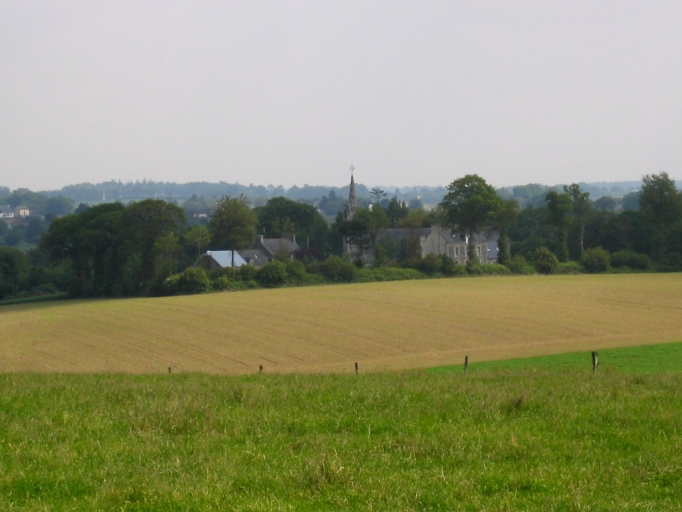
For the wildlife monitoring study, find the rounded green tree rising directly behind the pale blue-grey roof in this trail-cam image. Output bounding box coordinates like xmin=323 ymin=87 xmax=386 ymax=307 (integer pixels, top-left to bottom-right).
xmin=208 ymin=195 xmax=257 ymax=265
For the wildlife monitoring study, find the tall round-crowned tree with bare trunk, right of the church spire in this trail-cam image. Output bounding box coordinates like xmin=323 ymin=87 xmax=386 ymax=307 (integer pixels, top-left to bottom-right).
xmin=441 ymin=174 xmax=502 ymax=263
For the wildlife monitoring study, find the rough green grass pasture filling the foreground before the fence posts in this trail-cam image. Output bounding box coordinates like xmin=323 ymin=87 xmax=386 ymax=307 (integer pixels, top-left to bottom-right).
xmin=0 ymin=368 xmax=682 ymax=511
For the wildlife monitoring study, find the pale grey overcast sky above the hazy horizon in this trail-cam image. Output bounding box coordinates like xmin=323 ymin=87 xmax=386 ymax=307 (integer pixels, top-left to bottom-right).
xmin=0 ymin=0 xmax=682 ymax=190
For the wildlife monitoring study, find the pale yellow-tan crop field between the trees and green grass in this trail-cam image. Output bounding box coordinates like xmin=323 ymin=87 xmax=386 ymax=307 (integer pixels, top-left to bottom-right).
xmin=0 ymin=274 xmax=682 ymax=374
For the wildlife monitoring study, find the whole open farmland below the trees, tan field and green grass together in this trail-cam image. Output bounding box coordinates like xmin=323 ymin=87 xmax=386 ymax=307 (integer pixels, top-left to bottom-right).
xmin=0 ymin=274 xmax=682 ymax=511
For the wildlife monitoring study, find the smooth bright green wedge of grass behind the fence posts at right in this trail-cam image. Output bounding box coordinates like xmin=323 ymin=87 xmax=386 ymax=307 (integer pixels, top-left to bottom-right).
xmin=429 ymin=343 xmax=682 ymax=374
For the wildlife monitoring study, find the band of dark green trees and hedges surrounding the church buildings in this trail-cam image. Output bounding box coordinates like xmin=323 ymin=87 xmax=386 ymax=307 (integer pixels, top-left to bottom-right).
xmin=0 ymin=173 xmax=682 ymax=299
